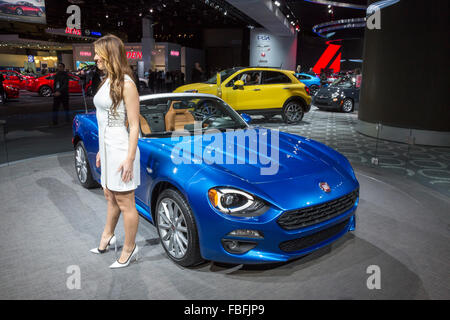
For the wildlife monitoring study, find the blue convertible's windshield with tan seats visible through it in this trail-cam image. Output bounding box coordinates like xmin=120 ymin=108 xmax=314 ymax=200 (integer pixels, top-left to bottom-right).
xmin=140 ymin=94 xmax=248 ymax=137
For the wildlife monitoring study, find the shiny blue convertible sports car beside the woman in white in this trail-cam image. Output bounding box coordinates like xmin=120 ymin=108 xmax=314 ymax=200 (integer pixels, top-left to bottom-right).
xmin=73 ymin=93 xmax=359 ymax=266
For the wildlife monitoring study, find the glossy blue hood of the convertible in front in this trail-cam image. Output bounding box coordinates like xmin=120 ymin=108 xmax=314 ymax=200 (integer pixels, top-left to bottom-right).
xmin=146 ymin=128 xmax=350 ymax=184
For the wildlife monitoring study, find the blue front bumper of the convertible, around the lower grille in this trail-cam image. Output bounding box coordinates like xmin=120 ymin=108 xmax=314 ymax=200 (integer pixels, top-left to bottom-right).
xmin=194 ymin=197 xmax=359 ymax=264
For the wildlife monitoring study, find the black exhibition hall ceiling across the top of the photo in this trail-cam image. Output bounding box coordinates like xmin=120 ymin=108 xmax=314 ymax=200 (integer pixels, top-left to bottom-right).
xmin=0 ymin=0 xmax=367 ymax=48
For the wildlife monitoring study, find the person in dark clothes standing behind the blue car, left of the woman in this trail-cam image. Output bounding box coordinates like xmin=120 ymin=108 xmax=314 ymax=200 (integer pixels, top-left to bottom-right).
xmin=53 ymin=63 xmax=70 ymax=125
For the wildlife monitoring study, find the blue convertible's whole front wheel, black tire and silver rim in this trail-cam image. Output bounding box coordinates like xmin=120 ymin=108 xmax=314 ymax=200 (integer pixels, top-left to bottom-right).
xmin=155 ymin=188 xmax=204 ymax=267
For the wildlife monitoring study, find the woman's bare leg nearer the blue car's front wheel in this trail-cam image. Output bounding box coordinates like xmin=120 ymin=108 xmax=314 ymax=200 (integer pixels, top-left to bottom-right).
xmin=114 ymin=190 xmax=139 ymax=263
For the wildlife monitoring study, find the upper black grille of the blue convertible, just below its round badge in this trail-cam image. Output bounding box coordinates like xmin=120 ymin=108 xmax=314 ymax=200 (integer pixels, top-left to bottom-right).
xmin=277 ymin=189 xmax=359 ymax=230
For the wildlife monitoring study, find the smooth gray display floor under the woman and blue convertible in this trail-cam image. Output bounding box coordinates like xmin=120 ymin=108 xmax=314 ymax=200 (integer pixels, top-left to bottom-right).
xmin=0 ymin=153 xmax=450 ymax=300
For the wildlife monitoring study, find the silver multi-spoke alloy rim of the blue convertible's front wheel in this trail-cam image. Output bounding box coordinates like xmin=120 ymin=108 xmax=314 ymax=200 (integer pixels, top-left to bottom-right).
xmin=157 ymin=198 xmax=189 ymax=259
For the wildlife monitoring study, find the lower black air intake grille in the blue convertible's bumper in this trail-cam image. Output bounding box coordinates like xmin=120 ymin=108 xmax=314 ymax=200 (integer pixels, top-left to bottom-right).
xmin=279 ymin=219 xmax=350 ymax=252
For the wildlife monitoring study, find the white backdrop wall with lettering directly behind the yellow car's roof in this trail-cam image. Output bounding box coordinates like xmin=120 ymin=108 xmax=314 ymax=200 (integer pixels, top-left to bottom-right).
xmin=250 ymin=29 xmax=297 ymax=70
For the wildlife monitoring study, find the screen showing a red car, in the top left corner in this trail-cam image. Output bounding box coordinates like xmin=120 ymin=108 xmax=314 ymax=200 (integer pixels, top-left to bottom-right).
xmin=0 ymin=0 xmax=47 ymax=24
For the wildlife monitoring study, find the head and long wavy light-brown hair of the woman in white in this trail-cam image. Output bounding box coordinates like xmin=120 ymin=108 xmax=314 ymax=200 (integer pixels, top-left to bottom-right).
xmin=94 ymin=34 xmax=133 ymax=115
